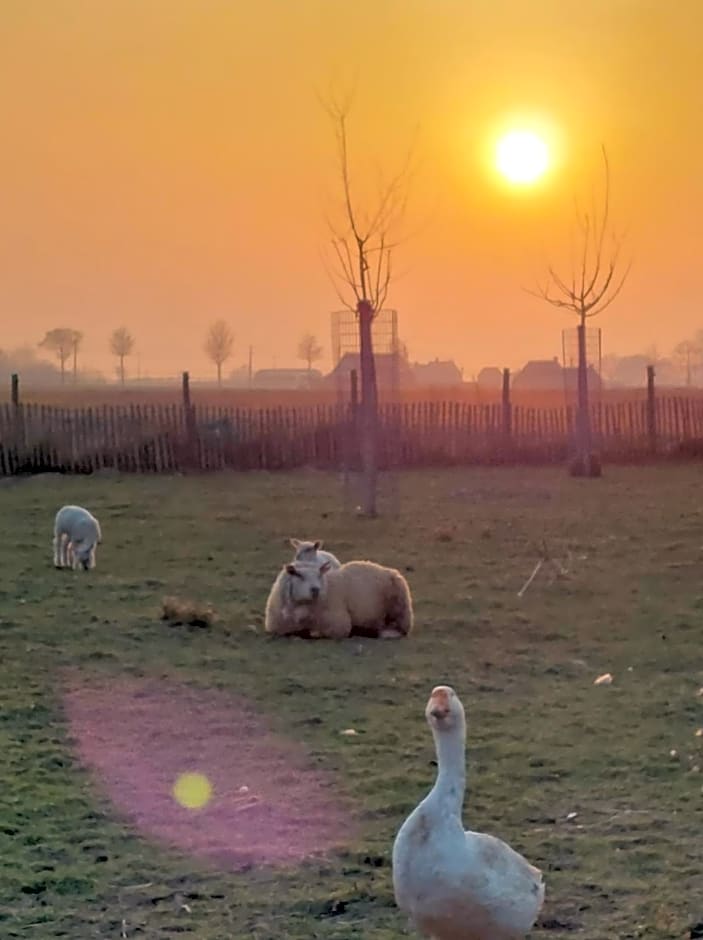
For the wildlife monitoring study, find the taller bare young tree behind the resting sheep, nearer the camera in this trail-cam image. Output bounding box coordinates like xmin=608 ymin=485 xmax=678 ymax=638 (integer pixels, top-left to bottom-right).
xmin=324 ymin=98 xmax=410 ymax=516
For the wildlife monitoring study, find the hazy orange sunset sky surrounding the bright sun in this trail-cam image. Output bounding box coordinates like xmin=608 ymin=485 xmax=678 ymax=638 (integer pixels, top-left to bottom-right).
xmin=0 ymin=0 xmax=703 ymax=375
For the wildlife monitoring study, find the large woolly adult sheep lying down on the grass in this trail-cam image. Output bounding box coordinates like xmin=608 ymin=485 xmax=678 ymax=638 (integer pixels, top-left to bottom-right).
xmin=266 ymin=561 xmax=413 ymax=639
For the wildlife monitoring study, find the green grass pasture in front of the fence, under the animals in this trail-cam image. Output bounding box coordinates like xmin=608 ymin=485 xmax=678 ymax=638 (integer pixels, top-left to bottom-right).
xmin=0 ymin=466 xmax=703 ymax=940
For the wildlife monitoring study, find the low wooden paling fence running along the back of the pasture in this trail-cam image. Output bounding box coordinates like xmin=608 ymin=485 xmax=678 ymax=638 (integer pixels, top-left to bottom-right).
xmin=0 ymin=397 xmax=703 ymax=476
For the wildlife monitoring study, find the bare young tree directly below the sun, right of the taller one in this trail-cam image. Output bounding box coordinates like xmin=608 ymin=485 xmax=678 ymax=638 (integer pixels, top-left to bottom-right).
xmin=528 ymin=146 xmax=631 ymax=476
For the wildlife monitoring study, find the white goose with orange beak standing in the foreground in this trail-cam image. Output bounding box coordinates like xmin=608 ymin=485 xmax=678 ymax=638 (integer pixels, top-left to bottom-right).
xmin=393 ymin=685 xmax=545 ymax=940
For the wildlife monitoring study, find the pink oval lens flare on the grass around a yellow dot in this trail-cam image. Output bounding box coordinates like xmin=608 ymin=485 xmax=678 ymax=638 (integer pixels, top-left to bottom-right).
xmin=64 ymin=675 xmax=355 ymax=870
